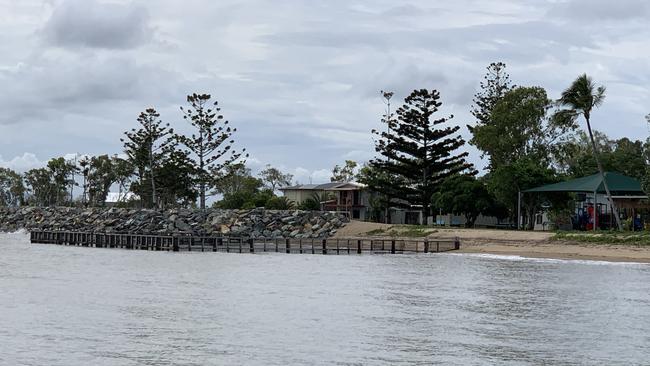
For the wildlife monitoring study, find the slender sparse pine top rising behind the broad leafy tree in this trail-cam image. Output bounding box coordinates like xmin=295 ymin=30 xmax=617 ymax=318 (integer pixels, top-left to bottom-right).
xmin=467 ymin=62 xmax=514 ymax=145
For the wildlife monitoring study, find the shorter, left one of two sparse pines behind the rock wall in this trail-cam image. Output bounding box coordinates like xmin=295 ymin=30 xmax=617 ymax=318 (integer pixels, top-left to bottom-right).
xmin=121 ymin=108 xmax=176 ymax=207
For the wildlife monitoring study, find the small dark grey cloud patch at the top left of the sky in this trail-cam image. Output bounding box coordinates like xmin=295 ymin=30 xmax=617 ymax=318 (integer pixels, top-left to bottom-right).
xmin=43 ymin=0 xmax=152 ymax=49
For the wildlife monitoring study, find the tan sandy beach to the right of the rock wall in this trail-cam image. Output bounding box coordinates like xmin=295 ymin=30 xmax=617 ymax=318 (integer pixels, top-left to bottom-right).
xmin=336 ymin=221 xmax=650 ymax=263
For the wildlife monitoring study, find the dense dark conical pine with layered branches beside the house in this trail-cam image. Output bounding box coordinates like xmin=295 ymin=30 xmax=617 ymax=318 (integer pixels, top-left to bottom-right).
xmin=370 ymin=89 xmax=472 ymax=222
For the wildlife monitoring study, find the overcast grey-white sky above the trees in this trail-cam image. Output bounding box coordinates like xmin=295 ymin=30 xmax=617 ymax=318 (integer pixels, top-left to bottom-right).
xmin=0 ymin=0 xmax=650 ymax=183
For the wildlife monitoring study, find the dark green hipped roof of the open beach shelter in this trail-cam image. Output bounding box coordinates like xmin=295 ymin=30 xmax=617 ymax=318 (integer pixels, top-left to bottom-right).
xmin=524 ymin=172 xmax=646 ymax=196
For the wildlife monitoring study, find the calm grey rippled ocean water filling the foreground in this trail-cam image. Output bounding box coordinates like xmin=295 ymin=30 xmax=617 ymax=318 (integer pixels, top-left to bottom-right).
xmin=0 ymin=234 xmax=650 ymax=366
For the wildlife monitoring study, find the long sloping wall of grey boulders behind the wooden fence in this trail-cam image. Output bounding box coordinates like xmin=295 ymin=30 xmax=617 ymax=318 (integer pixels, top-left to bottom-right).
xmin=0 ymin=207 xmax=347 ymax=238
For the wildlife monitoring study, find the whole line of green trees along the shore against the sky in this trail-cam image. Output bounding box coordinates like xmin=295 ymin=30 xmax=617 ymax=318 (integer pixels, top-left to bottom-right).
xmin=0 ymin=62 xmax=650 ymax=225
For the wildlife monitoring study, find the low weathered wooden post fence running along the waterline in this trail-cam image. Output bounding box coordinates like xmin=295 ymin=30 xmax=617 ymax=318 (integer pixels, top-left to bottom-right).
xmin=30 ymin=231 xmax=460 ymax=254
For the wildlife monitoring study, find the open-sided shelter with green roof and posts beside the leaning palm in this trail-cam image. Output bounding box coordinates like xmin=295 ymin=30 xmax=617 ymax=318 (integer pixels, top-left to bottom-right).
xmin=517 ymin=172 xmax=649 ymax=230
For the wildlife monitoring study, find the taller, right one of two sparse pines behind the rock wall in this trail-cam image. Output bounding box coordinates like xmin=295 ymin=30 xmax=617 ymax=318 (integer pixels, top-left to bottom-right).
xmin=179 ymin=93 xmax=248 ymax=209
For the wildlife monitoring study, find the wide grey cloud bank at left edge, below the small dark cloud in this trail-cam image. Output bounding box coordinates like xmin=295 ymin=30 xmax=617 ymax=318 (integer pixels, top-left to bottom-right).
xmin=0 ymin=55 xmax=180 ymax=124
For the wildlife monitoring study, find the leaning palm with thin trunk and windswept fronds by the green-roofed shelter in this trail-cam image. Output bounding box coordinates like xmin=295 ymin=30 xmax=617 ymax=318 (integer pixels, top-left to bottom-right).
xmin=558 ymin=74 xmax=623 ymax=230
